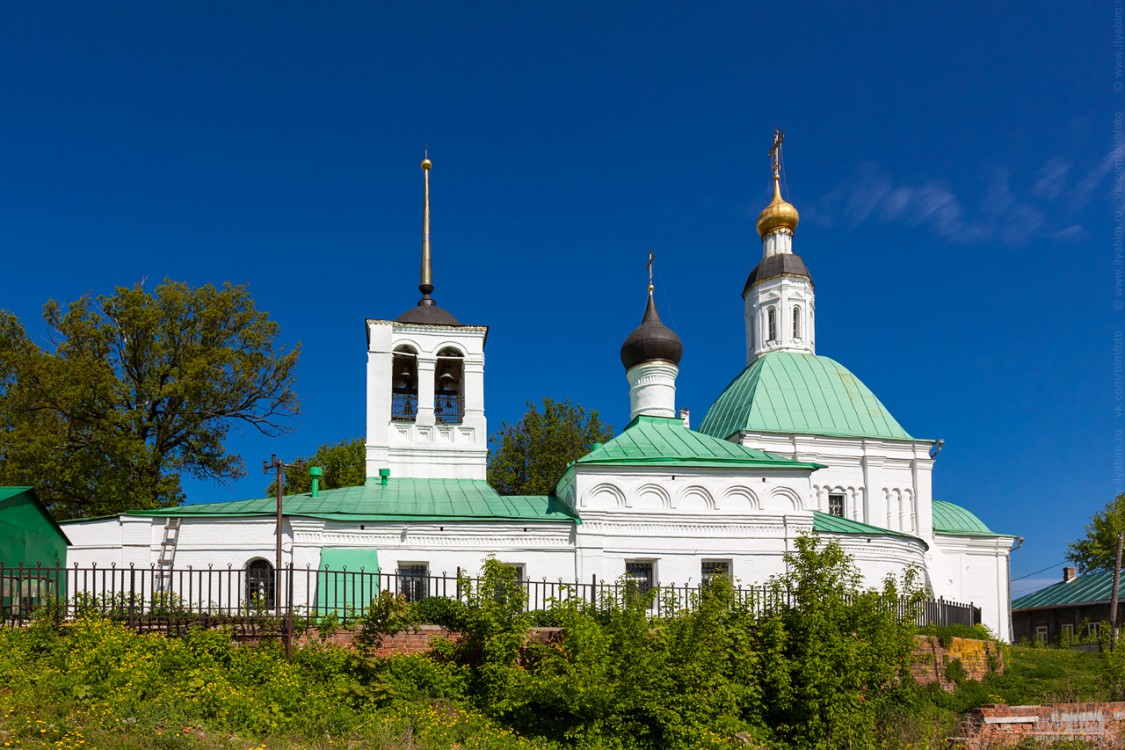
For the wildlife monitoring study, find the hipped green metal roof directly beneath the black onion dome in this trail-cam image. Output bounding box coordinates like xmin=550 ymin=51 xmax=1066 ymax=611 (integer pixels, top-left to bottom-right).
xmin=575 ymin=416 xmax=824 ymax=470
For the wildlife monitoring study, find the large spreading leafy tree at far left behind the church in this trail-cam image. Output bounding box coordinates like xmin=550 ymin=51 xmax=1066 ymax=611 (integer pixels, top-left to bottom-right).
xmin=0 ymin=280 xmax=299 ymax=516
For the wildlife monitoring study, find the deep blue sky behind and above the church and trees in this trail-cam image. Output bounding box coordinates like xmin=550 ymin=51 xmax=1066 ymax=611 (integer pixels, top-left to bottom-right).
xmin=0 ymin=2 xmax=1125 ymax=594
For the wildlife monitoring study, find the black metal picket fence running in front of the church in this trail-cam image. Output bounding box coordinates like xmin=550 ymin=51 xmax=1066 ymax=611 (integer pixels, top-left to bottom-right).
xmin=0 ymin=564 xmax=981 ymax=635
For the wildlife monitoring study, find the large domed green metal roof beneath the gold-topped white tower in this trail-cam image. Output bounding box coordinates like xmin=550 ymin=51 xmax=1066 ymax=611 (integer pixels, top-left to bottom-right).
xmin=699 ymin=352 xmax=914 ymax=440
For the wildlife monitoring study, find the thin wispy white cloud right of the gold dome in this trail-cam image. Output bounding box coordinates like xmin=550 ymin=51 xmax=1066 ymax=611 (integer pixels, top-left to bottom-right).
xmin=802 ymin=146 xmax=1125 ymax=245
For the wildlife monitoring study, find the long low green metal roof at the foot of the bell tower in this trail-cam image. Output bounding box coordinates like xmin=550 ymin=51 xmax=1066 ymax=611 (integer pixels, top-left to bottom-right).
xmin=128 ymin=477 xmax=576 ymax=523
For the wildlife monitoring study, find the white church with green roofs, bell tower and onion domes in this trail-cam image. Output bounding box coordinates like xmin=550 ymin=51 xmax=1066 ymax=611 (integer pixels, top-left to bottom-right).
xmin=65 ymin=135 xmax=1016 ymax=639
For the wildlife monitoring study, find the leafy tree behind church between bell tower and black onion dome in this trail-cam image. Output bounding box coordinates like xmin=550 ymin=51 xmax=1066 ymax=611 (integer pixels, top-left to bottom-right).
xmin=488 ymin=398 xmax=613 ymax=495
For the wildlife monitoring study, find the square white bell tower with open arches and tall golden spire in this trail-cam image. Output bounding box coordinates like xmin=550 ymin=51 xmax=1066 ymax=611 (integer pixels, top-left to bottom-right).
xmin=367 ymin=156 xmax=488 ymax=479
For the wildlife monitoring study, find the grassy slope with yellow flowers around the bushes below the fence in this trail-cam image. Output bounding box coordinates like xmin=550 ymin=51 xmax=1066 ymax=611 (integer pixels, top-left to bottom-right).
xmin=0 ymin=621 xmax=1125 ymax=750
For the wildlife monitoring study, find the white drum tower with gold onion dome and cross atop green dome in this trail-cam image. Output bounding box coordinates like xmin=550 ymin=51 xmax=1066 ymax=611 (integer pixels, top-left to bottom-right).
xmin=743 ymin=130 xmax=817 ymax=364
